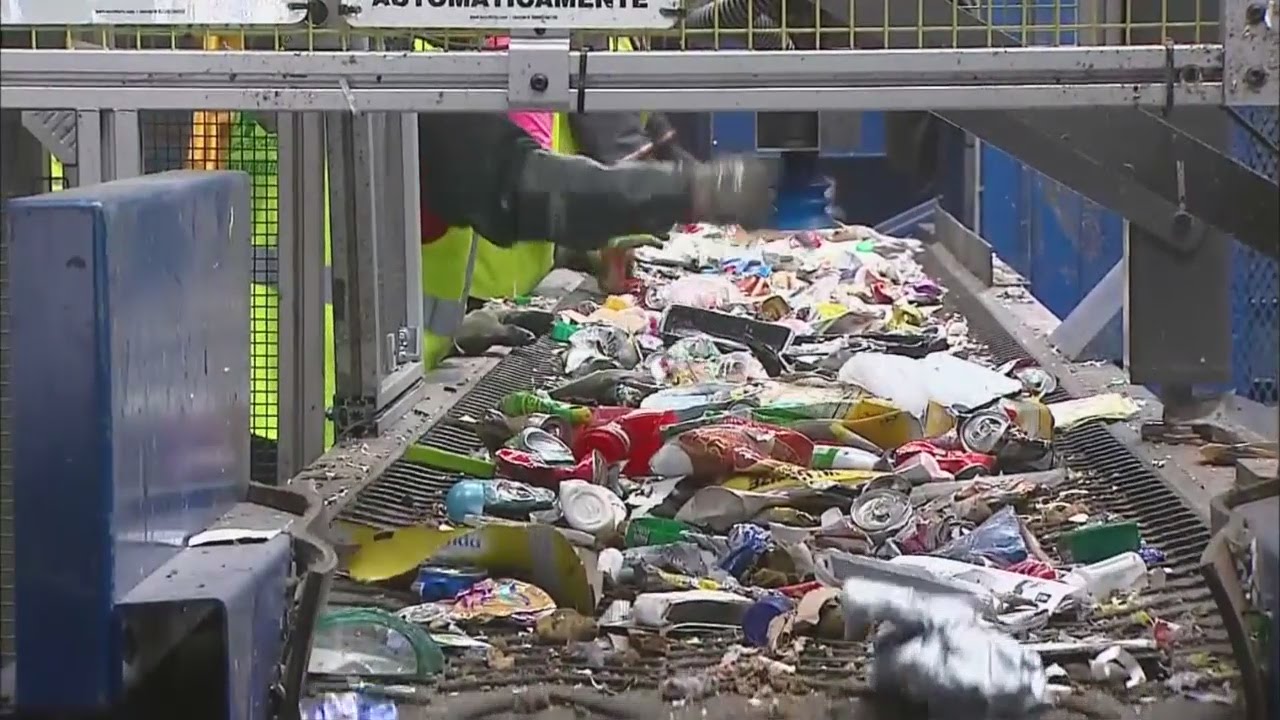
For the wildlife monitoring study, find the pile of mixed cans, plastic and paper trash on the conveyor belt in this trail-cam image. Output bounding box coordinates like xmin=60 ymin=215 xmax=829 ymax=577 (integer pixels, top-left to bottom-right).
xmin=305 ymin=225 xmax=1224 ymax=717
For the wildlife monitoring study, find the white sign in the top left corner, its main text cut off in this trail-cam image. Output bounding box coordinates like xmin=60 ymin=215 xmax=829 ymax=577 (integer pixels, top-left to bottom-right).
xmin=0 ymin=0 xmax=306 ymax=26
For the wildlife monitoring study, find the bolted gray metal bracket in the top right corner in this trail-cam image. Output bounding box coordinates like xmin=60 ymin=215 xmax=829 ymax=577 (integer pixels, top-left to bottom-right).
xmin=1222 ymin=0 xmax=1280 ymax=106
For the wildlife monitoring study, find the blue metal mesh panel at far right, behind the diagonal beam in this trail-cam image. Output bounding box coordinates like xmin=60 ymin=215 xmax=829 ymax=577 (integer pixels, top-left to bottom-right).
xmin=1231 ymin=108 xmax=1280 ymax=405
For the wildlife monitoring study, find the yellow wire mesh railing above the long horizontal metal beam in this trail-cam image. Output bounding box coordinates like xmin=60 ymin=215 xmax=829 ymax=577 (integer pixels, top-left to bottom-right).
xmin=6 ymin=0 xmax=1220 ymax=50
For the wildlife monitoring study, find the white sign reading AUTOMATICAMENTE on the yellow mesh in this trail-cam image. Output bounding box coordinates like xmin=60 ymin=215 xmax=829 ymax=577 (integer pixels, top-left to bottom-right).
xmin=347 ymin=0 xmax=680 ymax=29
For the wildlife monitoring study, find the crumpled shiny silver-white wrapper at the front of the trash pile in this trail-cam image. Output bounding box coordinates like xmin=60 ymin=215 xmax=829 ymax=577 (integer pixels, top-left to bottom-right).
xmin=841 ymin=578 xmax=1048 ymax=720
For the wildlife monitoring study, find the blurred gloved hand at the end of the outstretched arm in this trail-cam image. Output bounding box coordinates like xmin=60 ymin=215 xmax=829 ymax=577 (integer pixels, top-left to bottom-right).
xmin=681 ymin=156 xmax=774 ymax=229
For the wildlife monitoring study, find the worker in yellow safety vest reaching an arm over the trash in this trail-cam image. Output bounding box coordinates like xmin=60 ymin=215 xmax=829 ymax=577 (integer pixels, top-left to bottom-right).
xmin=419 ymin=113 xmax=772 ymax=363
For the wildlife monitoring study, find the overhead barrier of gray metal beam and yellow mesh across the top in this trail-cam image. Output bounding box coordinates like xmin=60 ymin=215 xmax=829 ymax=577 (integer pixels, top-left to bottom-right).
xmin=4 ymin=0 xmax=1280 ymax=111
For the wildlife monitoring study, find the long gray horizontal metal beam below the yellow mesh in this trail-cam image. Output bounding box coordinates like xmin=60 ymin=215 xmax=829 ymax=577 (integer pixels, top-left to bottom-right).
xmin=0 ymin=42 xmax=1224 ymax=114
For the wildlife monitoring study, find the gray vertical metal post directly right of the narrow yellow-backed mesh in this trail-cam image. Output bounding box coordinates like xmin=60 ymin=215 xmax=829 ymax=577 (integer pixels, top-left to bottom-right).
xmin=276 ymin=113 xmax=333 ymax=482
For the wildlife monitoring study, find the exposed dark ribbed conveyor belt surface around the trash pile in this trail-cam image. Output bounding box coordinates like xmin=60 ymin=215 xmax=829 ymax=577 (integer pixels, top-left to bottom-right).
xmin=333 ymin=249 xmax=1229 ymax=694
